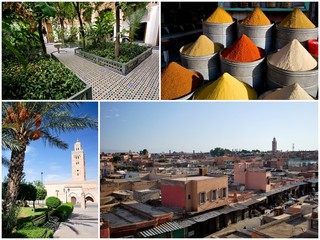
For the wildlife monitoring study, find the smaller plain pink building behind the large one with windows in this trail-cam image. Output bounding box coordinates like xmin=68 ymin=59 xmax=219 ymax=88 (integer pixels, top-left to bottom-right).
xmin=234 ymin=162 xmax=271 ymax=192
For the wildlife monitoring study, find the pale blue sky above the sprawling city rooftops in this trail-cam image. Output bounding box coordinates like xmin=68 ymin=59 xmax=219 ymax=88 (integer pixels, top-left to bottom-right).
xmin=100 ymin=101 xmax=318 ymax=153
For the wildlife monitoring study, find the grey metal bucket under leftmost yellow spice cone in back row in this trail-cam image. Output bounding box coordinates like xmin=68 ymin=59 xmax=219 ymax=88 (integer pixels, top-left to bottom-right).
xmin=202 ymin=21 xmax=237 ymax=47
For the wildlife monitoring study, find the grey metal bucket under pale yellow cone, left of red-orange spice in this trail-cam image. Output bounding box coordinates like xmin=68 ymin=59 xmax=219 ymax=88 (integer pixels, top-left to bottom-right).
xmin=180 ymin=43 xmax=223 ymax=81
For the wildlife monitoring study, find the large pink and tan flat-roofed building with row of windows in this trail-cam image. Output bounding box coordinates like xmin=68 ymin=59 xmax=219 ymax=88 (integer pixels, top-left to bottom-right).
xmin=161 ymin=176 xmax=228 ymax=212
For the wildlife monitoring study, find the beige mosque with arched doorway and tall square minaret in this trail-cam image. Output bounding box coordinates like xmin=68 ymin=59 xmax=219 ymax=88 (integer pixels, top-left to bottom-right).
xmin=44 ymin=140 xmax=99 ymax=208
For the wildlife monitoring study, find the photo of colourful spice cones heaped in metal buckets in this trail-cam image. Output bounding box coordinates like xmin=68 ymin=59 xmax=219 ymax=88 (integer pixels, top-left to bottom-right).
xmin=161 ymin=1 xmax=318 ymax=100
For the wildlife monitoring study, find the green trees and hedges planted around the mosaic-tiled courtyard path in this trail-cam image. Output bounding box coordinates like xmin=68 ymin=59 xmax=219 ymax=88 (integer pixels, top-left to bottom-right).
xmin=2 ymin=2 xmax=151 ymax=100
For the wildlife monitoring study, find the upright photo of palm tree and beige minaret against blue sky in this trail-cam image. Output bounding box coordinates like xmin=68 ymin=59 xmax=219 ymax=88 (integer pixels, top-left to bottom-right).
xmin=2 ymin=102 xmax=99 ymax=238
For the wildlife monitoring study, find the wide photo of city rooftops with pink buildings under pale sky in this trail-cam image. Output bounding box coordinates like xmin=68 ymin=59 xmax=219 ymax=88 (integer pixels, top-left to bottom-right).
xmin=100 ymin=101 xmax=319 ymax=238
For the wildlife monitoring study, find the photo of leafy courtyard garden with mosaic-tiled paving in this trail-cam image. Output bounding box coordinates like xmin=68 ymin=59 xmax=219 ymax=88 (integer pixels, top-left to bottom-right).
xmin=1 ymin=2 xmax=160 ymax=100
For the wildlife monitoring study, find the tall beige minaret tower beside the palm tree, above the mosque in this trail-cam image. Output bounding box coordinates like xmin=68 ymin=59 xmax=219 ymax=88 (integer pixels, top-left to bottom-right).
xmin=71 ymin=139 xmax=86 ymax=182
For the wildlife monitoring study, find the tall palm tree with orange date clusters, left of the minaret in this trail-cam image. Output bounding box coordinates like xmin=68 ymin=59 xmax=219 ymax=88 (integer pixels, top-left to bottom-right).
xmin=2 ymin=102 xmax=98 ymax=219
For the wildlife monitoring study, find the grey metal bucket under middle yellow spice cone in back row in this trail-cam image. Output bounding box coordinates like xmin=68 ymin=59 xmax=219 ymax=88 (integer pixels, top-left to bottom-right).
xmin=237 ymin=22 xmax=274 ymax=53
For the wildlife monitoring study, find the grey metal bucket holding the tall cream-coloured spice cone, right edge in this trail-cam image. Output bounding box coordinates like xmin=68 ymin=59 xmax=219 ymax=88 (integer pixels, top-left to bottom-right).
xmin=267 ymin=54 xmax=318 ymax=98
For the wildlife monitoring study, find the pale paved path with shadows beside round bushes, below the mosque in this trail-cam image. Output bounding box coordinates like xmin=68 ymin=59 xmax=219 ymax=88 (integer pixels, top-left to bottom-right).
xmin=53 ymin=203 xmax=99 ymax=238
